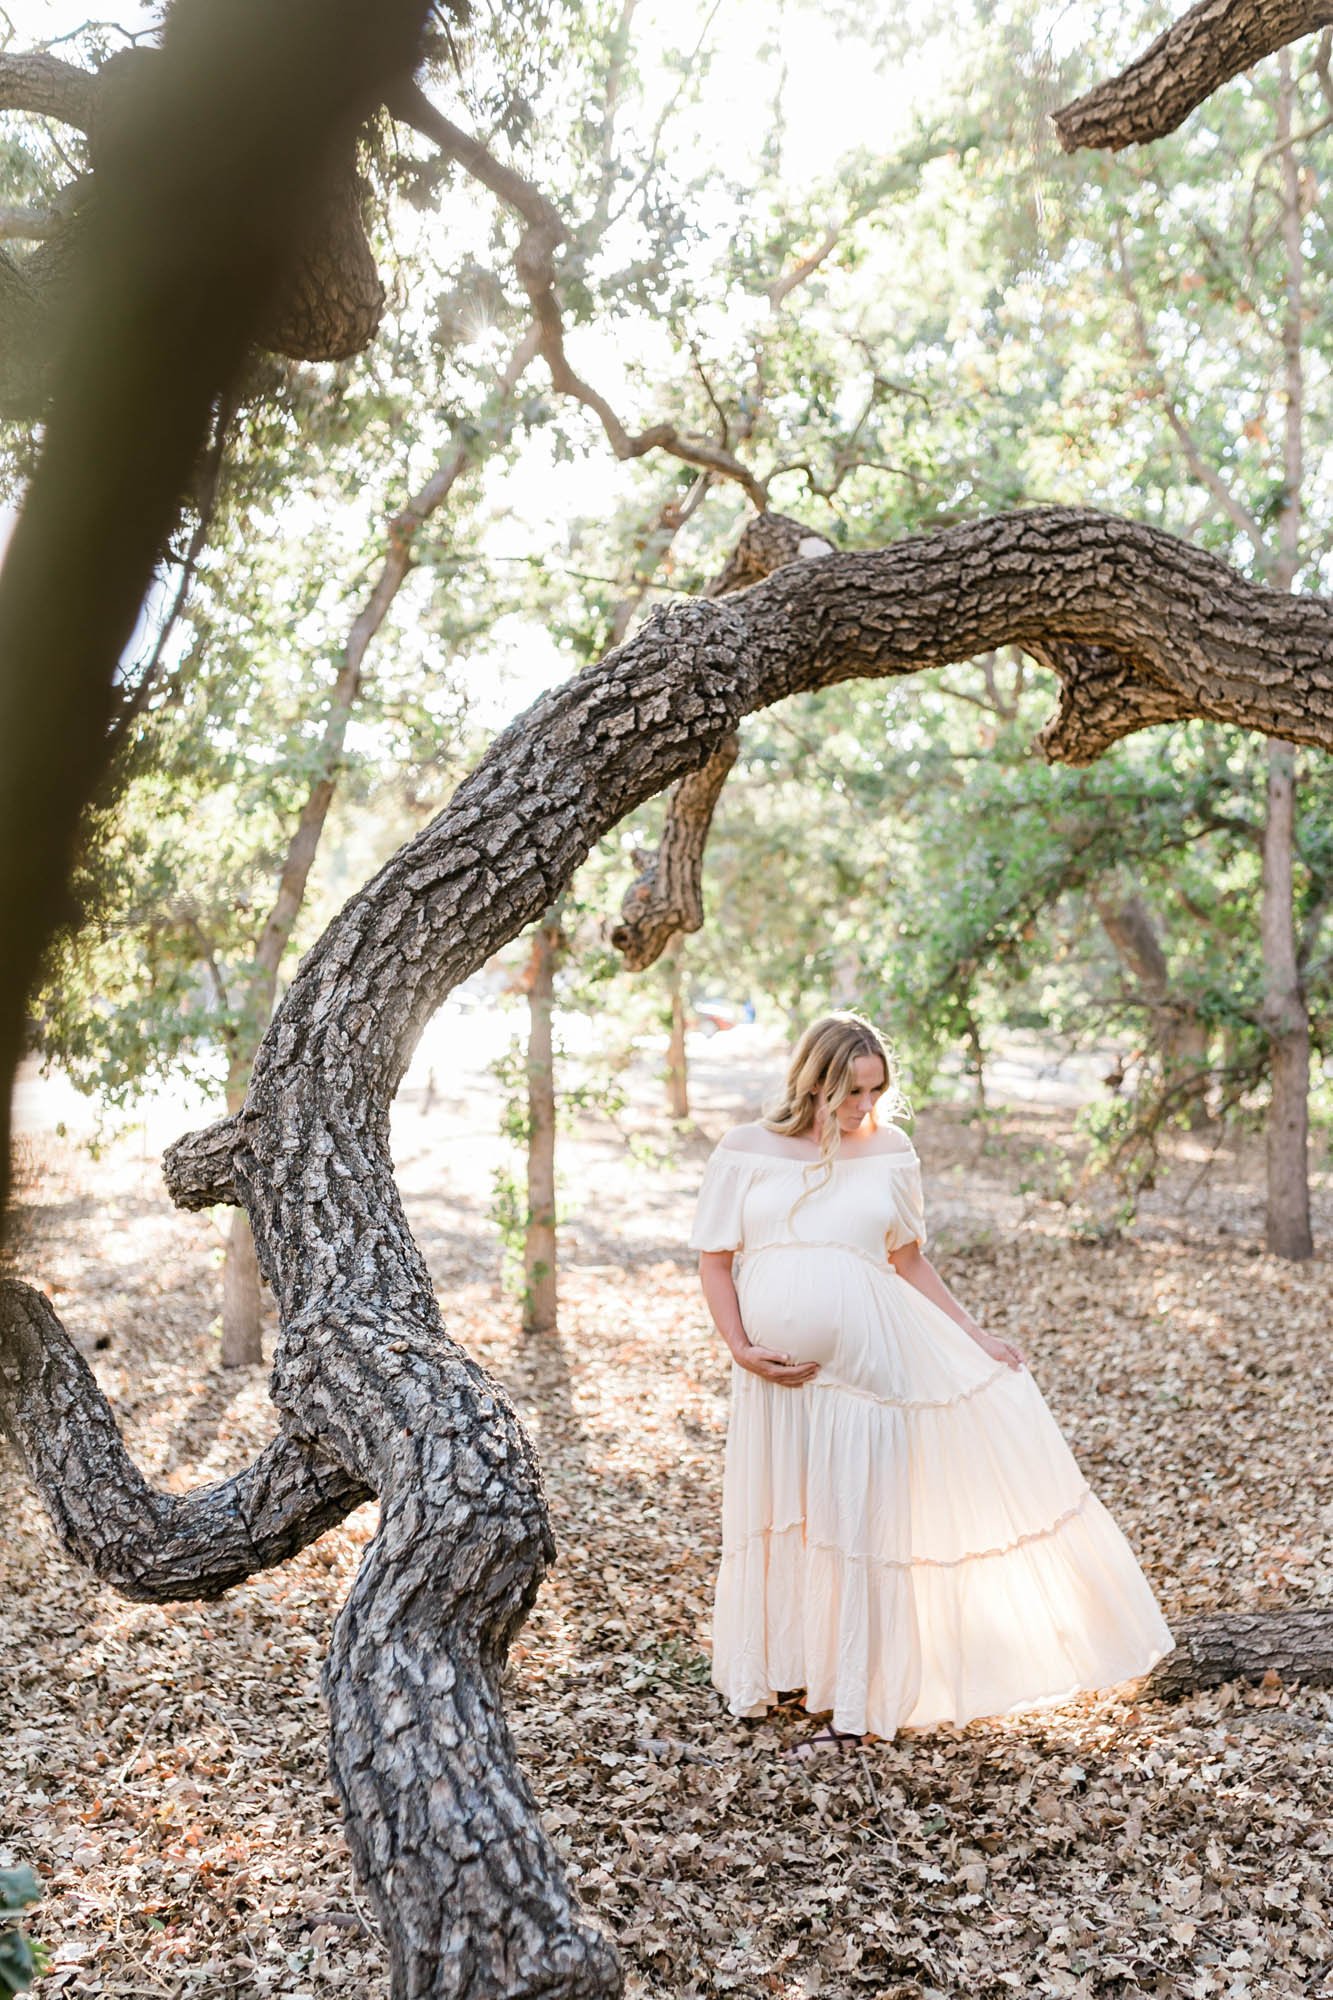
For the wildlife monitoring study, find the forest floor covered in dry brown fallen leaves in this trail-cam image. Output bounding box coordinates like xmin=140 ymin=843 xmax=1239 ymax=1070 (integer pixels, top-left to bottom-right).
xmin=0 ymin=1030 xmax=1333 ymax=2000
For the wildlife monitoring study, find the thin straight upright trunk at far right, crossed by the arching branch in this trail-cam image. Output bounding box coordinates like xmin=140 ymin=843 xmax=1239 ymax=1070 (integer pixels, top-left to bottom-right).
xmin=1261 ymin=50 xmax=1315 ymax=1258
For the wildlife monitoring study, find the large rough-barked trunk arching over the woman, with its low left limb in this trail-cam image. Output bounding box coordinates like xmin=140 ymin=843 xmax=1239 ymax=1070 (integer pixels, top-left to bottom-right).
xmin=13 ymin=508 xmax=1333 ymax=2000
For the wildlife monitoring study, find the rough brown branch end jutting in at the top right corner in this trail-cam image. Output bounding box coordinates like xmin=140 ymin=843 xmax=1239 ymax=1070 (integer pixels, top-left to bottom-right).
xmin=1051 ymin=0 xmax=1333 ymax=152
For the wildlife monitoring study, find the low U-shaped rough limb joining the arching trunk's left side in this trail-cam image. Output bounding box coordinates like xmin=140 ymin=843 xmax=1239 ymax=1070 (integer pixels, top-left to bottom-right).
xmin=0 ymin=1280 xmax=372 ymax=1604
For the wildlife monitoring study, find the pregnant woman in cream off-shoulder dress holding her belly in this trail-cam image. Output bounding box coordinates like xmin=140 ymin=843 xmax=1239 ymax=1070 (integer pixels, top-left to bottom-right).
xmin=691 ymin=1012 xmax=1173 ymax=1752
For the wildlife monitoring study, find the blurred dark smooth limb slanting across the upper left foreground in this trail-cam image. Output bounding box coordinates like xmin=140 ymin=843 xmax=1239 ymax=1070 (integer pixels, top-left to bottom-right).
xmin=0 ymin=0 xmax=430 ymax=1214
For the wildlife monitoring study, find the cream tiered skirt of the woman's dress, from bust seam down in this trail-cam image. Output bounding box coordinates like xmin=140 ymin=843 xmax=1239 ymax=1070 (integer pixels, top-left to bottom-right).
xmin=713 ymin=1244 xmax=1173 ymax=1738
